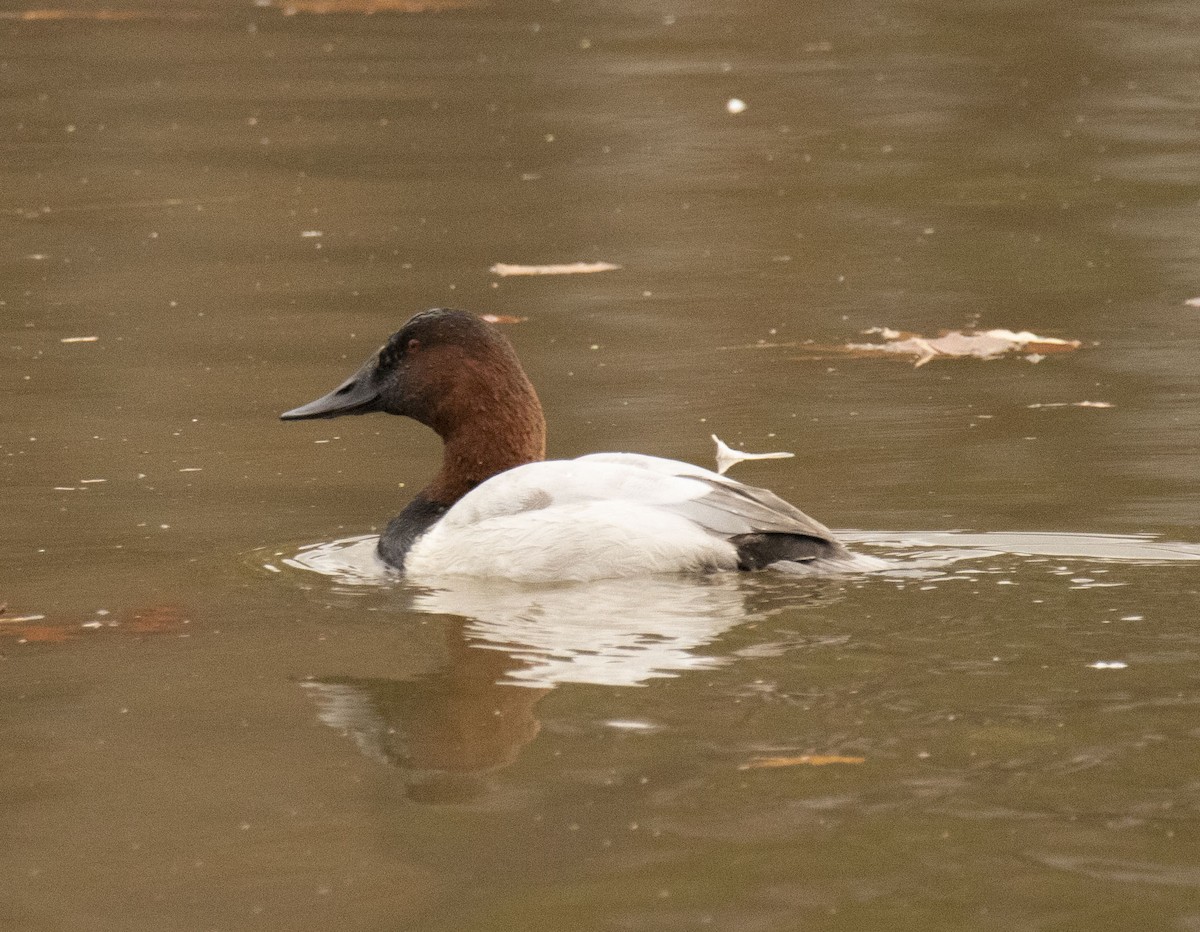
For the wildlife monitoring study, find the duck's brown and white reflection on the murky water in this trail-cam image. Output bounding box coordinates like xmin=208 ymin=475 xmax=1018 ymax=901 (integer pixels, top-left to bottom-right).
xmin=289 ymin=541 xmax=755 ymax=802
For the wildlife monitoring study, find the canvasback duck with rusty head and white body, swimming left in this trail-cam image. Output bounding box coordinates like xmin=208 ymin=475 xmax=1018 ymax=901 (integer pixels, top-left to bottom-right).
xmin=281 ymin=308 xmax=870 ymax=582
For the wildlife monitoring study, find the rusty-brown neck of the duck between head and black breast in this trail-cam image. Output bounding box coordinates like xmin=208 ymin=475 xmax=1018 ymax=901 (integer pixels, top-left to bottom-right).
xmin=421 ymin=387 xmax=546 ymax=506
